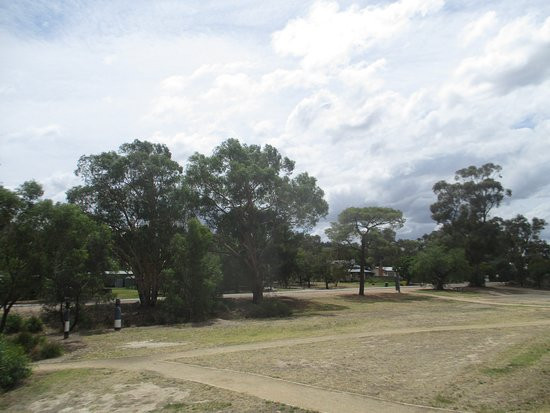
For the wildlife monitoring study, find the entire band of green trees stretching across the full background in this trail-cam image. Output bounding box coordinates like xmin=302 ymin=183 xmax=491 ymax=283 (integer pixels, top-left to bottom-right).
xmin=0 ymin=139 xmax=550 ymax=330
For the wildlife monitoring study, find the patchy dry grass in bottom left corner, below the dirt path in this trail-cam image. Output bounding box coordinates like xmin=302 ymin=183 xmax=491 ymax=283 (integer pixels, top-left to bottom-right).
xmin=0 ymin=369 xmax=306 ymax=413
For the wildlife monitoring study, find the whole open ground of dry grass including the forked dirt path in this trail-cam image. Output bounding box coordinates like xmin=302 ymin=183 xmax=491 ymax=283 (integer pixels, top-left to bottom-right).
xmin=0 ymin=287 xmax=550 ymax=412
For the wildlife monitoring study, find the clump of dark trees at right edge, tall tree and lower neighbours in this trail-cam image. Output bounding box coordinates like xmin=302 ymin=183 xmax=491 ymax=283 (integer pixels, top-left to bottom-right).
xmin=401 ymin=163 xmax=550 ymax=288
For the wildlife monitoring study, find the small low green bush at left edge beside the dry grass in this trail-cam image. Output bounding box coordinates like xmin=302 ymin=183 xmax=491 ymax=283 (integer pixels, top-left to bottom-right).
xmin=0 ymin=337 xmax=31 ymax=390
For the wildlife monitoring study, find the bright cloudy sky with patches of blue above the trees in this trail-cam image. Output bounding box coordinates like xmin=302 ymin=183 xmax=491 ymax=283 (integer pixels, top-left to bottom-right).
xmin=0 ymin=0 xmax=550 ymax=239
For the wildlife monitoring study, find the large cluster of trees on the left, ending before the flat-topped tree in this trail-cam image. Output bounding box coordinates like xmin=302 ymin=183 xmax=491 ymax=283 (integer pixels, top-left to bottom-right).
xmin=0 ymin=139 xmax=328 ymax=328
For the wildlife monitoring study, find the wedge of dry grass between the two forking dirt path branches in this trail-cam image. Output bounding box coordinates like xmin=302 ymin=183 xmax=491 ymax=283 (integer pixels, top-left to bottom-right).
xmin=185 ymin=326 xmax=550 ymax=412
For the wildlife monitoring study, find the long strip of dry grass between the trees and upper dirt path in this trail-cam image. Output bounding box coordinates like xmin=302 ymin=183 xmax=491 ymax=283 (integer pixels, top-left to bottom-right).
xmin=60 ymin=293 xmax=550 ymax=360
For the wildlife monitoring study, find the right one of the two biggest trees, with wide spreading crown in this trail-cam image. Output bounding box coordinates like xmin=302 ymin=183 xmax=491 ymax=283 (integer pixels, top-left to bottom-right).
xmin=186 ymin=139 xmax=328 ymax=303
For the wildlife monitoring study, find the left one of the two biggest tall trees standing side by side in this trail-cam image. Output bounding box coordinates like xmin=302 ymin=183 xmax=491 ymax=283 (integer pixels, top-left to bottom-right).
xmin=67 ymin=140 xmax=187 ymax=306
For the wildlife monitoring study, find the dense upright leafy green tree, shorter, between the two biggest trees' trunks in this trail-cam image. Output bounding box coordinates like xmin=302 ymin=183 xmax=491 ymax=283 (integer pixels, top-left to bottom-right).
xmin=164 ymin=219 xmax=221 ymax=320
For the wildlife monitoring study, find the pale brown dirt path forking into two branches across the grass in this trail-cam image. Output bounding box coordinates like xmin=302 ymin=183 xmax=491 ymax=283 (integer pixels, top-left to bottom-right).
xmin=36 ymin=319 xmax=550 ymax=413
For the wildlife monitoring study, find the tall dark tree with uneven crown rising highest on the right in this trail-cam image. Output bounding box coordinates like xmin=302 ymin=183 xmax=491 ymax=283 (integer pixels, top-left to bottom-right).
xmin=430 ymin=163 xmax=512 ymax=286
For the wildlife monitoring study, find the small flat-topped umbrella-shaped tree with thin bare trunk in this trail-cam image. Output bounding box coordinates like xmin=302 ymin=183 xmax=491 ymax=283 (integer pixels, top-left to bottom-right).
xmin=325 ymin=207 xmax=405 ymax=295
